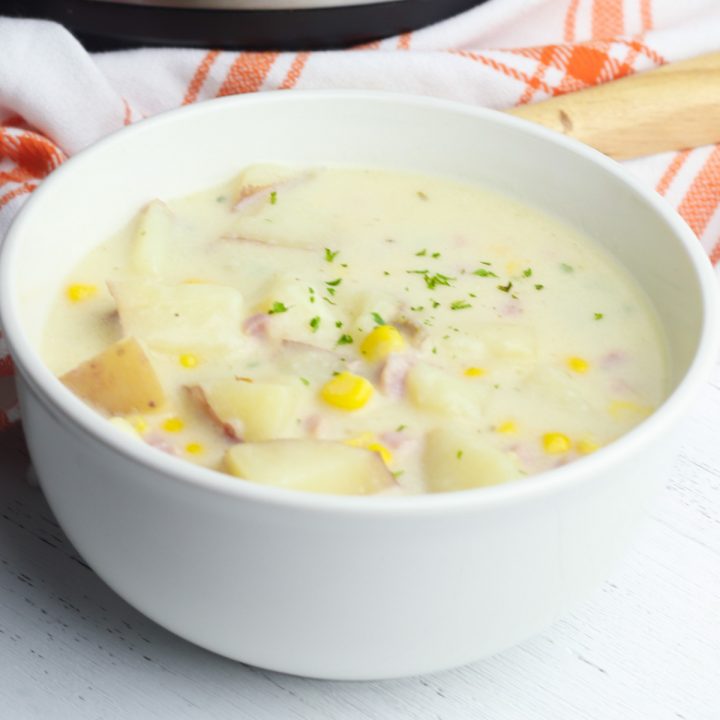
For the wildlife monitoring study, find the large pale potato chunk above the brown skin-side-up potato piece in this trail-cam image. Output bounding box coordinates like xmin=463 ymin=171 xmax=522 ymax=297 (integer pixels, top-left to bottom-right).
xmin=110 ymin=280 xmax=243 ymax=354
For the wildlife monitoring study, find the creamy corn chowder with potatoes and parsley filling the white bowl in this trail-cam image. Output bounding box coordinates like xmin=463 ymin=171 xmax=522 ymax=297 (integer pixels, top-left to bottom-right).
xmin=44 ymin=166 xmax=665 ymax=494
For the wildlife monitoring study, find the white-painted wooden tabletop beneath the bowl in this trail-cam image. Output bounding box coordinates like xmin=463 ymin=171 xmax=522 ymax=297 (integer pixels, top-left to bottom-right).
xmin=0 ymin=365 xmax=720 ymax=720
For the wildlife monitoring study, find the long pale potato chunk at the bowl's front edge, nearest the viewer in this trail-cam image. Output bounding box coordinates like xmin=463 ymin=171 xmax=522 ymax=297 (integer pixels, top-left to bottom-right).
xmin=225 ymin=440 xmax=394 ymax=495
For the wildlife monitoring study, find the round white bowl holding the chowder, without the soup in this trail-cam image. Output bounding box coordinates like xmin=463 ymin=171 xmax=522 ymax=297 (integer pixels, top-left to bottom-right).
xmin=0 ymin=92 xmax=718 ymax=679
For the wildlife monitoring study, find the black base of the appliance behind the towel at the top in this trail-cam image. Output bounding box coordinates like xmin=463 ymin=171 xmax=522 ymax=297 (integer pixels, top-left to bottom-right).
xmin=2 ymin=0 xmax=485 ymax=50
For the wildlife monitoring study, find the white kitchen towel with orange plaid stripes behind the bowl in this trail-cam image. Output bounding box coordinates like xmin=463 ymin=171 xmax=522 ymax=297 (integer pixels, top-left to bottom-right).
xmin=0 ymin=0 xmax=720 ymax=427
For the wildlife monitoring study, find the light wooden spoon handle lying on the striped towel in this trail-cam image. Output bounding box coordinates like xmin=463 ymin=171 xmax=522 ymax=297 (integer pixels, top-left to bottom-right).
xmin=508 ymin=53 xmax=720 ymax=159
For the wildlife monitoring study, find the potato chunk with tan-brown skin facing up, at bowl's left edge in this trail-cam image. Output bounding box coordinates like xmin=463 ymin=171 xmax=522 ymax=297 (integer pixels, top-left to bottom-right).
xmin=60 ymin=337 xmax=165 ymax=415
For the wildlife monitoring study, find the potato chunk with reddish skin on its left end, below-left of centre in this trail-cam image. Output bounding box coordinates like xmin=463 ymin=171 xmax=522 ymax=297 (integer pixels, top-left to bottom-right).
xmin=189 ymin=379 xmax=306 ymax=442
